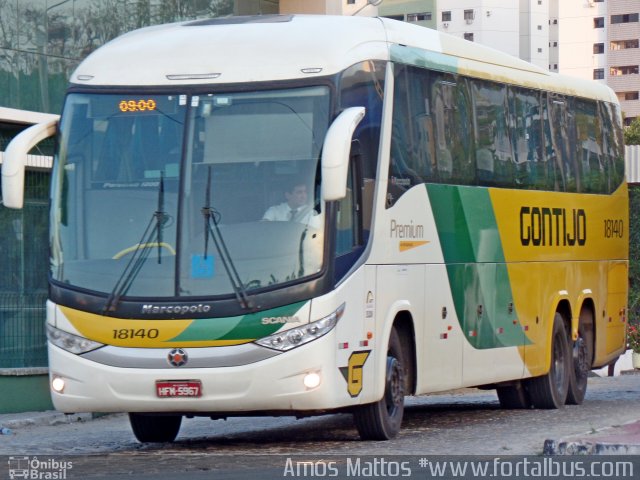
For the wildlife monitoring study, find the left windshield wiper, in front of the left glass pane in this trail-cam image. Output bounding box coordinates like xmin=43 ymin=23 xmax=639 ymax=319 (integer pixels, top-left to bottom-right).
xmin=102 ymin=172 xmax=169 ymax=314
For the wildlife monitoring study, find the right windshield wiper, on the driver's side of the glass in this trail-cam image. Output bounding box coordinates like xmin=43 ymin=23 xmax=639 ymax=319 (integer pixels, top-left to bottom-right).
xmin=201 ymin=165 xmax=253 ymax=310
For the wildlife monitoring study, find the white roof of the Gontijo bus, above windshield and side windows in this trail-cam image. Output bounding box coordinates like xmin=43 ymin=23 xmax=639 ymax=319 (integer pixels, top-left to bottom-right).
xmin=71 ymin=15 xmax=617 ymax=102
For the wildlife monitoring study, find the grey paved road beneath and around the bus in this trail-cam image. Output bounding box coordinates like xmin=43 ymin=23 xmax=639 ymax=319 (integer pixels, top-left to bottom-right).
xmin=0 ymin=375 xmax=640 ymax=478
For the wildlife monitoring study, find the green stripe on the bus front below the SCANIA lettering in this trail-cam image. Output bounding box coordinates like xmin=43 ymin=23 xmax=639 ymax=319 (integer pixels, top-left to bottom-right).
xmin=170 ymin=301 xmax=306 ymax=342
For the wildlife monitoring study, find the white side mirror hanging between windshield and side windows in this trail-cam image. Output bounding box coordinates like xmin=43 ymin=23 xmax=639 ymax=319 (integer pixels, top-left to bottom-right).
xmin=322 ymin=107 xmax=365 ymax=202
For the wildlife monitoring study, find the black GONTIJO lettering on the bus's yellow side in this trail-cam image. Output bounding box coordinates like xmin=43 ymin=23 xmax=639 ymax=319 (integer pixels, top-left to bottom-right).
xmin=520 ymin=207 xmax=587 ymax=247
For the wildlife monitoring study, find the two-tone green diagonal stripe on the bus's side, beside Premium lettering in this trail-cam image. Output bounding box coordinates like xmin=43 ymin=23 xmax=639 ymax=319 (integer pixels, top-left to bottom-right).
xmin=427 ymin=184 xmax=531 ymax=349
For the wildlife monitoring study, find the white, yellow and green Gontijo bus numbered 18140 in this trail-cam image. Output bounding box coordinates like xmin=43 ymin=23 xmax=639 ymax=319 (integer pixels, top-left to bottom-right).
xmin=2 ymin=15 xmax=629 ymax=442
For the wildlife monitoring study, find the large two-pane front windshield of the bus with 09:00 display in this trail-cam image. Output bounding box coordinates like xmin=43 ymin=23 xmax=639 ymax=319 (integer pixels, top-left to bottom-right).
xmin=51 ymin=87 xmax=330 ymax=300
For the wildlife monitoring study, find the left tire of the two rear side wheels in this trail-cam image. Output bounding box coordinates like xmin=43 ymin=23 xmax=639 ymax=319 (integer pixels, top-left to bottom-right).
xmin=526 ymin=312 xmax=571 ymax=409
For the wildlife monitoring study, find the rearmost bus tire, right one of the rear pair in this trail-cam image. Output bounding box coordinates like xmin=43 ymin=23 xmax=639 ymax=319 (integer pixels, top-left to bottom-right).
xmin=567 ymin=309 xmax=593 ymax=405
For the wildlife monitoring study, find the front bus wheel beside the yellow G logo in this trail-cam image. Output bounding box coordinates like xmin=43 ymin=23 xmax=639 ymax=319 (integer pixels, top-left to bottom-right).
xmin=353 ymin=327 xmax=405 ymax=440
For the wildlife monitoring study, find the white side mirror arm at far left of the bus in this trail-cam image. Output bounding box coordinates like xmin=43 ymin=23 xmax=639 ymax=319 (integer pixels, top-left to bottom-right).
xmin=2 ymin=119 xmax=58 ymax=208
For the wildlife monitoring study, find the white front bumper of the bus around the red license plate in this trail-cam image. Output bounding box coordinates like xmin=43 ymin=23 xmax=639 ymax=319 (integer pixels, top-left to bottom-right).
xmin=49 ymin=332 xmax=362 ymax=414
